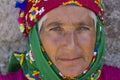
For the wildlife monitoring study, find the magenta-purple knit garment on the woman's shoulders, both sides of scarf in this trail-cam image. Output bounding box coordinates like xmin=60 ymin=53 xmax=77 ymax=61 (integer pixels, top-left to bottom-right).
xmin=0 ymin=65 xmax=120 ymax=80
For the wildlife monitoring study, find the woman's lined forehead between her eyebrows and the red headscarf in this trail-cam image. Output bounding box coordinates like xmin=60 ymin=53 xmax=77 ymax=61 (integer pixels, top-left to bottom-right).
xmin=45 ymin=6 xmax=93 ymax=27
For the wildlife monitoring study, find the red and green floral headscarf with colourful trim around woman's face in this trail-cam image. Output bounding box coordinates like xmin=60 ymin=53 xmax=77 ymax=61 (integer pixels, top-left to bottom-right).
xmin=8 ymin=0 xmax=105 ymax=80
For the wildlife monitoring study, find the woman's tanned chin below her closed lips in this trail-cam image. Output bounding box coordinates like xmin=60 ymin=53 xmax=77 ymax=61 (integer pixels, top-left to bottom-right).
xmin=56 ymin=58 xmax=89 ymax=77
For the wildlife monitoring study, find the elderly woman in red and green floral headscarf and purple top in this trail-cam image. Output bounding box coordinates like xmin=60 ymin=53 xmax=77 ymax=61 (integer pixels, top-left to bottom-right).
xmin=0 ymin=0 xmax=120 ymax=80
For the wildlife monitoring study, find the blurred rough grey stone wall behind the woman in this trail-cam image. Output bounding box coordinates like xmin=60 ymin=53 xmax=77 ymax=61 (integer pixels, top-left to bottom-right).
xmin=0 ymin=0 xmax=120 ymax=74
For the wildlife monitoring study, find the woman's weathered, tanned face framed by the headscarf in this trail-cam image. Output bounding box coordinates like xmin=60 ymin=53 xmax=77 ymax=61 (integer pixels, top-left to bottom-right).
xmin=40 ymin=6 xmax=96 ymax=77
